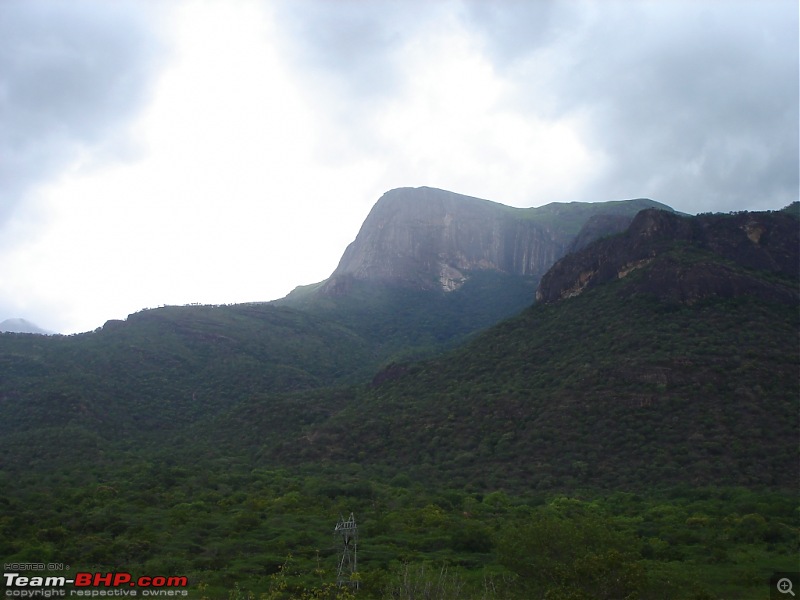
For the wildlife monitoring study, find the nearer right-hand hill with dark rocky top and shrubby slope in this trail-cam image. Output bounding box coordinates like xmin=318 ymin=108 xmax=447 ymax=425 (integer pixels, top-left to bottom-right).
xmin=216 ymin=210 xmax=800 ymax=490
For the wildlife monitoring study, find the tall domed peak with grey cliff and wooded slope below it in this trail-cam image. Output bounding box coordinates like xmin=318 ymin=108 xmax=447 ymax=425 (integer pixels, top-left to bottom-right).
xmin=278 ymin=187 xmax=672 ymax=362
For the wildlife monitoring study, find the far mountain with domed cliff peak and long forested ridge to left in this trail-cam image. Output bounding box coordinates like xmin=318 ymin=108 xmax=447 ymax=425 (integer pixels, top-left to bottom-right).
xmin=0 ymin=188 xmax=676 ymax=448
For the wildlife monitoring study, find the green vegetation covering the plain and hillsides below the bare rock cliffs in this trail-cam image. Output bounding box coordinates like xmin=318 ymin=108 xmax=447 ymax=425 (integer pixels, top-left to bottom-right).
xmin=0 ymin=207 xmax=800 ymax=600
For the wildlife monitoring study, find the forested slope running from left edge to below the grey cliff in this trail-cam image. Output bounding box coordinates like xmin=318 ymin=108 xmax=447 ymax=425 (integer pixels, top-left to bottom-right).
xmin=0 ymin=272 xmax=535 ymax=450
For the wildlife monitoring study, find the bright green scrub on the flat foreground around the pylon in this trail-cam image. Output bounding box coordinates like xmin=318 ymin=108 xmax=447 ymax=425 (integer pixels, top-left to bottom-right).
xmin=0 ymin=455 xmax=800 ymax=599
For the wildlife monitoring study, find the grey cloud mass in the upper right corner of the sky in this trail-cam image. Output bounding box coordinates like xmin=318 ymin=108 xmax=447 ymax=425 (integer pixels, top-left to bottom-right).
xmin=556 ymin=1 xmax=798 ymax=211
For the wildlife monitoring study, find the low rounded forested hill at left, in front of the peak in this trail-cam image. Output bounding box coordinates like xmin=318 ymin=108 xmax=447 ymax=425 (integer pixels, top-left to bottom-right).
xmin=0 ymin=304 xmax=371 ymax=468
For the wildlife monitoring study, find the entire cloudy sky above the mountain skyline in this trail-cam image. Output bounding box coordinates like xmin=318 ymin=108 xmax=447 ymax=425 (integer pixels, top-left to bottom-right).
xmin=0 ymin=0 xmax=800 ymax=334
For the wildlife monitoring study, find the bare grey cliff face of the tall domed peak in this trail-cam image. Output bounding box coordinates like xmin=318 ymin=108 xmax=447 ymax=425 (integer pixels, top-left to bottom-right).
xmin=321 ymin=187 xmax=666 ymax=295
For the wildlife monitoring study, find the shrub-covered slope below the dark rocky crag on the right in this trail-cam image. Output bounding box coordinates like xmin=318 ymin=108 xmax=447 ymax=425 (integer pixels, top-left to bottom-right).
xmin=260 ymin=282 xmax=800 ymax=490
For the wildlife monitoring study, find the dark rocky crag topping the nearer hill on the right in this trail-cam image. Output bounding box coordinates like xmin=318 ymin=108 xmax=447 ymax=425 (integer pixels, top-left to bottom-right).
xmin=536 ymin=209 xmax=800 ymax=304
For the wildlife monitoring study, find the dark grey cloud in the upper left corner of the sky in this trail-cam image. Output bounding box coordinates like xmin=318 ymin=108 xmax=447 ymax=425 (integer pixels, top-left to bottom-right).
xmin=0 ymin=0 xmax=166 ymax=225
